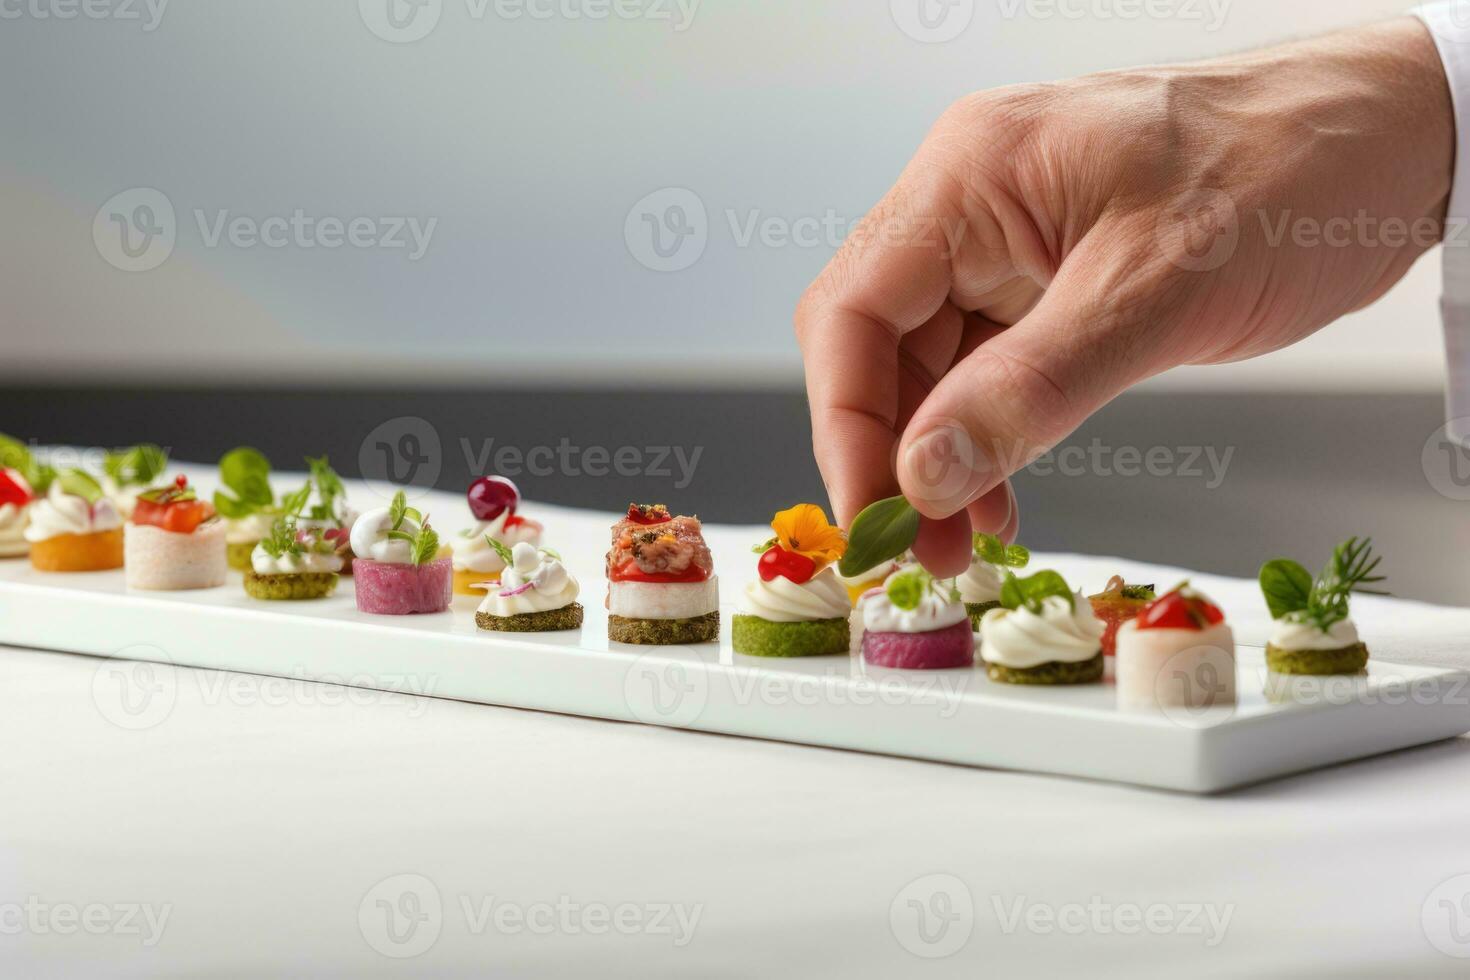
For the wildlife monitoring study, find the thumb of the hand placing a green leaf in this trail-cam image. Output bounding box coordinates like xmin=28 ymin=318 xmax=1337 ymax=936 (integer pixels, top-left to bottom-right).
xmin=897 ymin=263 xmax=1163 ymax=519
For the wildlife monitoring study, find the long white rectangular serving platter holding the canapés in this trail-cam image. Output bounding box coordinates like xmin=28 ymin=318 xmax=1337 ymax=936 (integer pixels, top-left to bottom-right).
xmin=0 ymin=561 xmax=1470 ymax=793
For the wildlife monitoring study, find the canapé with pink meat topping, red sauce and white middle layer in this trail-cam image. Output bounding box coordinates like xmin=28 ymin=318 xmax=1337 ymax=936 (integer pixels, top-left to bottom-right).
xmin=607 ymin=504 xmax=720 ymax=646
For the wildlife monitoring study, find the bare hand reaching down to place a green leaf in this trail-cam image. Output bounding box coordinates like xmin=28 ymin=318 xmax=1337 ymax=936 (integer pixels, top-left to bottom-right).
xmin=795 ymin=18 xmax=1454 ymax=574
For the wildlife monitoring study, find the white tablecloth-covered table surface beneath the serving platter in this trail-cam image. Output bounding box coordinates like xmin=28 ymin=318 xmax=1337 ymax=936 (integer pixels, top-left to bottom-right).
xmin=0 ymin=473 xmax=1470 ymax=980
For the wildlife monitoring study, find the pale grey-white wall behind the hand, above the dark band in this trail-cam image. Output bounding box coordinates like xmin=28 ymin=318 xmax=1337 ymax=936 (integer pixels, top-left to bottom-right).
xmin=0 ymin=0 xmax=1442 ymax=389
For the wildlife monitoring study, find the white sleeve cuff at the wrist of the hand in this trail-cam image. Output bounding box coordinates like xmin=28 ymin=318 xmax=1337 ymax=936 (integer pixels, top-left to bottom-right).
xmin=1414 ymin=0 xmax=1470 ymax=445
